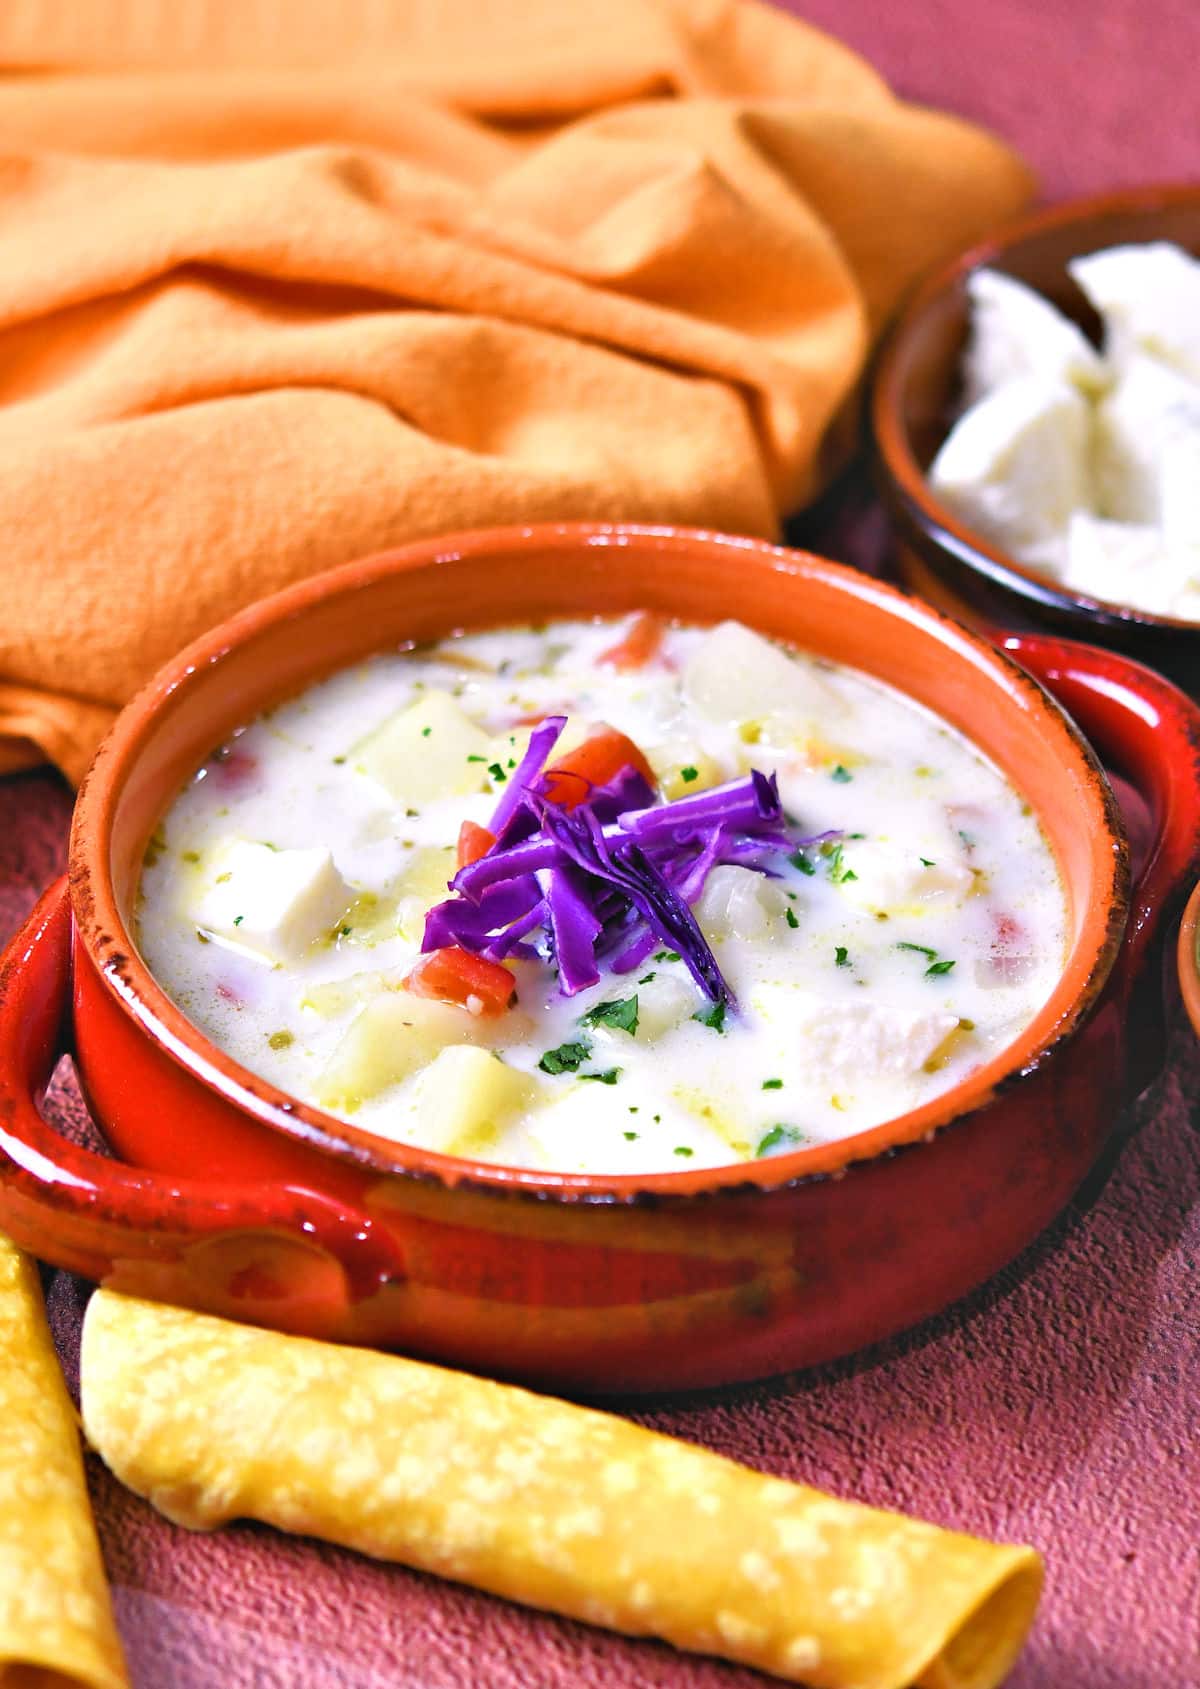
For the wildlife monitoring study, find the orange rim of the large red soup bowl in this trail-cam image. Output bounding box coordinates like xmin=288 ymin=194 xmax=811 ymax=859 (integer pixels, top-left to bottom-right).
xmin=69 ymin=524 xmax=1129 ymax=1204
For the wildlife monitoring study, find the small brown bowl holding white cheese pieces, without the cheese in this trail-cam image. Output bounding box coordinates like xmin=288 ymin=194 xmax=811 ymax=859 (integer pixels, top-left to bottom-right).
xmin=869 ymin=182 xmax=1200 ymax=692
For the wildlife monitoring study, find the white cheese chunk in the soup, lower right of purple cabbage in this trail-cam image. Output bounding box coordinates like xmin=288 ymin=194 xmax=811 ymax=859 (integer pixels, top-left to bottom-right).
xmin=750 ymin=985 xmax=958 ymax=1086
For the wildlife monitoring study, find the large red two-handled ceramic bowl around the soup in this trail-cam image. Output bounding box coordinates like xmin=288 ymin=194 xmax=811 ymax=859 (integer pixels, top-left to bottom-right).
xmin=0 ymin=527 xmax=1200 ymax=1393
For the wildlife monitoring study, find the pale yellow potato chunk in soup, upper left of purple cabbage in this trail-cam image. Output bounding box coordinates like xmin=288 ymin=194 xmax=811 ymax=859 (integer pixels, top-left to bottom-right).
xmin=353 ymin=691 xmax=495 ymax=806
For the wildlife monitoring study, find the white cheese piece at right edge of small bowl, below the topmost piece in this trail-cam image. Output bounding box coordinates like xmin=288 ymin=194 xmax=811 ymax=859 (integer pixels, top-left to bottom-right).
xmin=1094 ymin=355 xmax=1200 ymax=524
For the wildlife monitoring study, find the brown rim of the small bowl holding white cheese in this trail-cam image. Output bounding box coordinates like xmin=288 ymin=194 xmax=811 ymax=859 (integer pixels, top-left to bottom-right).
xmin=869 ymin=182 xmax=1200 ymax=633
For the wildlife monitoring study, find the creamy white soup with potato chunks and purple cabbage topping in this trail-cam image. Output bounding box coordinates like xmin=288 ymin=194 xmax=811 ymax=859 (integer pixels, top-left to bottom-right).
xmin=139 ymin=616 xmax=1066 ymax=1172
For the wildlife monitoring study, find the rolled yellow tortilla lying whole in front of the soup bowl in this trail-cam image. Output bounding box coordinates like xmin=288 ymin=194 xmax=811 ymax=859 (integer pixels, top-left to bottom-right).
xmin=83 ymin=1290 xmax=1041 ymax=1689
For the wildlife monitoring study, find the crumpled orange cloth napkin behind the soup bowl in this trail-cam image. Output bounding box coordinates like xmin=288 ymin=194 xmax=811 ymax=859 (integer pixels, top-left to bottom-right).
xmin=0 ymin=0 xmax=1031 ymax=779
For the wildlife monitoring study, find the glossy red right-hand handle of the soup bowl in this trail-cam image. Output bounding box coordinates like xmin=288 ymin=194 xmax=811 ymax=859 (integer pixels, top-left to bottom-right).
xmin=994 ymin=633 xmax=1200 ymax=1094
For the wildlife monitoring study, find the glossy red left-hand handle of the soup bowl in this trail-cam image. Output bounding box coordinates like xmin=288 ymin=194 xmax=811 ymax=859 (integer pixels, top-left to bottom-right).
xmin=0 ymin=880 xmax=404 ymax=1336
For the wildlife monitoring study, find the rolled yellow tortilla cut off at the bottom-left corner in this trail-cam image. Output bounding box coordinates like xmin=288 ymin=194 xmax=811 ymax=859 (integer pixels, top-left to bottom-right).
xmin=0 ymin=1236 xmax=128 ymax=1689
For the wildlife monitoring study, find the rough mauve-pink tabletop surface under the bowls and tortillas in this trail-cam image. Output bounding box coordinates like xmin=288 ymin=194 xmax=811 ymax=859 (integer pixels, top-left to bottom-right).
xmin=0 ymin=0 xmax=1200 ymax=1689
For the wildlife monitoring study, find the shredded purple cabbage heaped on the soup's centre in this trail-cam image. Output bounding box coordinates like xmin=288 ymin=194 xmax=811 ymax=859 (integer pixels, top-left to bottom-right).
xmin=421 ymin=736 xmax=813 ymax=1007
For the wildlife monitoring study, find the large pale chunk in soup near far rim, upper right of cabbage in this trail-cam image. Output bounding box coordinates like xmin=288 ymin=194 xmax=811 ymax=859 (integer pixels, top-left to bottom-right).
xmin=683 ymin=622 xmax=845 ymax=725
